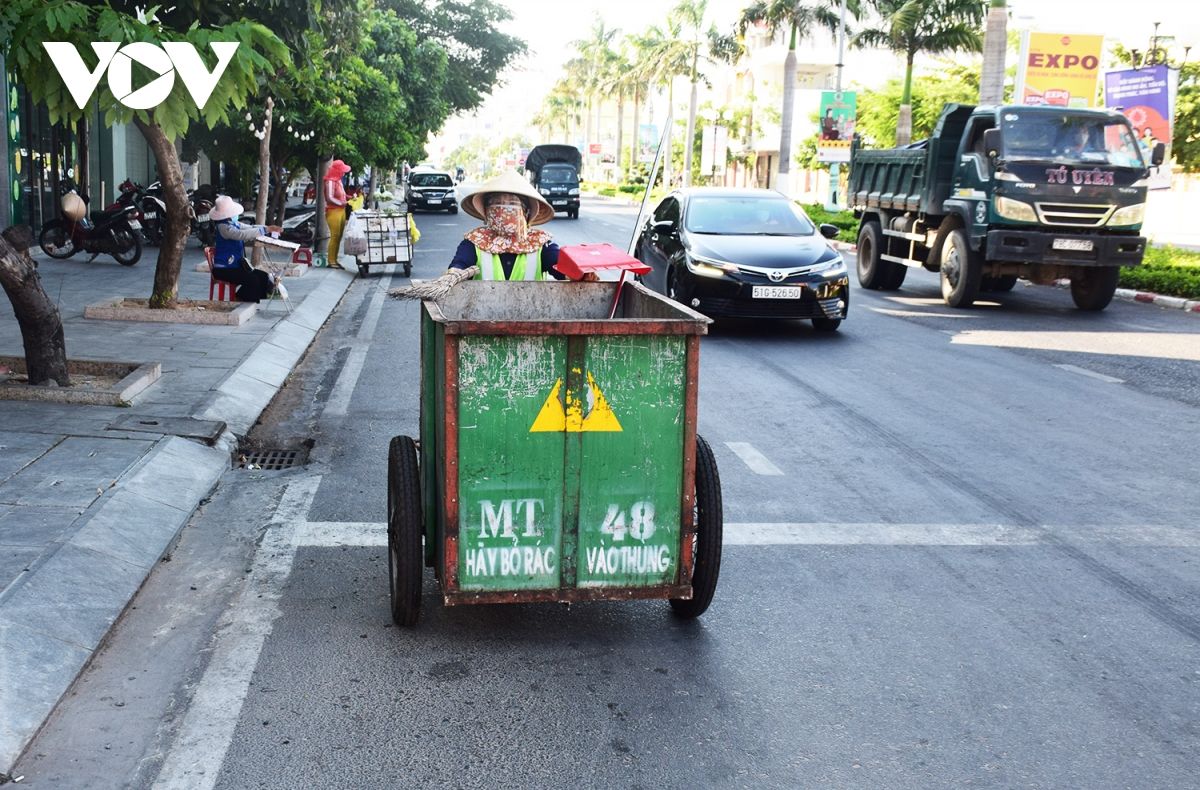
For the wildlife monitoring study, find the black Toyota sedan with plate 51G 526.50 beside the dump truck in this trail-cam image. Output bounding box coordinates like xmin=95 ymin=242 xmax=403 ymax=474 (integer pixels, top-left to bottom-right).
xmin=634 ymin=187 xmax=850 ymax=331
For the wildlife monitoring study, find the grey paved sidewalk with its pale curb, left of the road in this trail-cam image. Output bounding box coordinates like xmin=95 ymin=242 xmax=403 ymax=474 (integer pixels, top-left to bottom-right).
xmin=0 ymin=241 xmax=353 ymax=774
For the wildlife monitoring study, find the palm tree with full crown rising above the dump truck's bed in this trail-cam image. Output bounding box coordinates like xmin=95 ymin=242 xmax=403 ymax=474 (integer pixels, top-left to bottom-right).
xmin=853 ymin=0 xmax=983 ymax=145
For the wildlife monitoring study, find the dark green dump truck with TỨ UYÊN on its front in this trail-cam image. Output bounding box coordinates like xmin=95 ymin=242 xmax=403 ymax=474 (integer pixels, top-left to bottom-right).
xmin=850 ymin=104 xmax=1163 ymax=310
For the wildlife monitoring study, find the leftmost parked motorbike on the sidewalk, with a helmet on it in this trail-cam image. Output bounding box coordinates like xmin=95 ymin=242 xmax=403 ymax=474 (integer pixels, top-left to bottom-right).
xmin=37 ymin=179 xmax=142 ymax=267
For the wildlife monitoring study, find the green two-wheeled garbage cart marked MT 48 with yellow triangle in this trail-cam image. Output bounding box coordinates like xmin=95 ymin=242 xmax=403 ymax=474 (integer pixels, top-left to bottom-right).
xmin=388 ymin=281 xmax=722 ymax=626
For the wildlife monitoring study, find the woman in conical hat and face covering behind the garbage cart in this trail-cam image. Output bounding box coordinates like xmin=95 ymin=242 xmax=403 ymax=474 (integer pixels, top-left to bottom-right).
xmin=450 ymin=170 xmax=596 ymax=281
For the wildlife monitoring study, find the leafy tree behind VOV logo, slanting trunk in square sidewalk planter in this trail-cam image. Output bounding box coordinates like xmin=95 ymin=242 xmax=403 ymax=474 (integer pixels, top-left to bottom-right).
xmin=0 ymin=0 xmax=287 ymax=307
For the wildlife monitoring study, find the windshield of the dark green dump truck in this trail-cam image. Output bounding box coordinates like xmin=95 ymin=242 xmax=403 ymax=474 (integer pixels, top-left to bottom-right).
xmin=1002 ymin=112 xmax=1145 ymax=168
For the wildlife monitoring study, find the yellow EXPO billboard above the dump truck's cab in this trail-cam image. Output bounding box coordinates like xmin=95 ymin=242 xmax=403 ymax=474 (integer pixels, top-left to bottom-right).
xmin=1015 ymin=30 xmax=1104 ymax=107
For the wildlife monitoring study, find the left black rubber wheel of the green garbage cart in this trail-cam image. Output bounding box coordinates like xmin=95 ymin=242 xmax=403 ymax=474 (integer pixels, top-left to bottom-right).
xmin=388 ymin=436 xmax=425 ymax=626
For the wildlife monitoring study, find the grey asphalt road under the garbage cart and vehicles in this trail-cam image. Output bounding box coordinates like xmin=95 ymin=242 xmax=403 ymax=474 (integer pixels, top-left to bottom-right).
xmin=18 ymin=196 xmax=1200 ymax=789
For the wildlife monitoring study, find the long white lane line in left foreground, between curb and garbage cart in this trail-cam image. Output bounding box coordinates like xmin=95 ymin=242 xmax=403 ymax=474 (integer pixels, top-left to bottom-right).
xmin=154 ymin=475 xmax=320 ymax=790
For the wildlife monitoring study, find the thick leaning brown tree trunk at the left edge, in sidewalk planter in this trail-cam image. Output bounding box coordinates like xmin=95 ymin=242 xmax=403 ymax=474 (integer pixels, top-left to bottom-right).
xmin=0 ymin=225 xmax=71 ymax=387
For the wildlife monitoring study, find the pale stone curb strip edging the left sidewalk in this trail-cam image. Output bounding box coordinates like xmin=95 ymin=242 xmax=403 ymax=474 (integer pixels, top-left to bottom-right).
xmin=0 ymin=264 xmax=354 ymax=776
